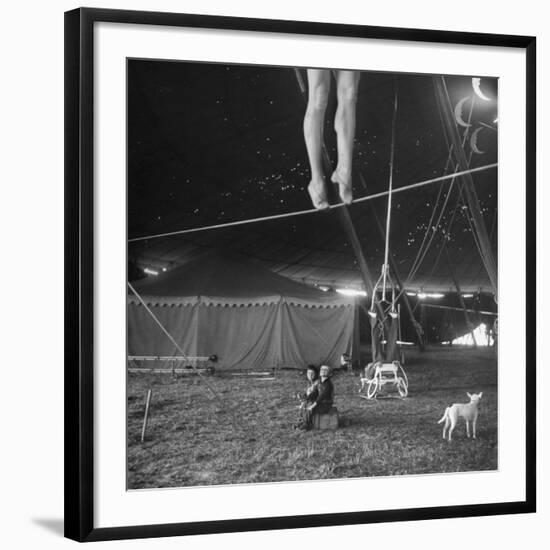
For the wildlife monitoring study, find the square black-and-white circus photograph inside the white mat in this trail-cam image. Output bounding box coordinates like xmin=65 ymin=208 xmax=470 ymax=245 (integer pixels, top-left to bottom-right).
xmin=126 ymin=58 xmax=502 ymax=490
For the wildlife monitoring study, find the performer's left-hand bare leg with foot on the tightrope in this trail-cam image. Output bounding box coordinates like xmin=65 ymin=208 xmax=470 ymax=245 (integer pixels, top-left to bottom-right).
xmin=304 ymin=69 xmax=330 ymax=209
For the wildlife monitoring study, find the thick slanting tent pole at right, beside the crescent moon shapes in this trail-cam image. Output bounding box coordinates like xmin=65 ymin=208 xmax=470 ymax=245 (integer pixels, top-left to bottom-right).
xmin=433 ymin=76 xmax=498 ymax=295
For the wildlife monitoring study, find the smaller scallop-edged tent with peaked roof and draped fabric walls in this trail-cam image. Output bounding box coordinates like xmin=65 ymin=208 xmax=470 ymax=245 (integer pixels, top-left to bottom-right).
xmin=128 ymin=253 xmax=355 ymax=370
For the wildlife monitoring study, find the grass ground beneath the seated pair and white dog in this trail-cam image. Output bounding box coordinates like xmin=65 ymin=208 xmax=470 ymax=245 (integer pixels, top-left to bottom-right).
xmin=128 ymin=348 xmax=498 ymax=489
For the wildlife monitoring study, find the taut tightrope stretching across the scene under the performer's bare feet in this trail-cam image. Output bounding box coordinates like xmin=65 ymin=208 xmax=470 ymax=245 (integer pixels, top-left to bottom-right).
xmin=128 ymin=162 xmax=498 ymax=243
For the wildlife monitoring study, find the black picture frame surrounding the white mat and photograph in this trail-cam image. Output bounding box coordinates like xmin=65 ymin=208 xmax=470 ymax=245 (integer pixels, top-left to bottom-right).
xmin=65 ymin=8 xmax=536 ymax=541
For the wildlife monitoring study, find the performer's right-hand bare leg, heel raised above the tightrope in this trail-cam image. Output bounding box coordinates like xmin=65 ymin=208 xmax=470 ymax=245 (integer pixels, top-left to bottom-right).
xmin=331 ymin=71 xmax=360 ymax=204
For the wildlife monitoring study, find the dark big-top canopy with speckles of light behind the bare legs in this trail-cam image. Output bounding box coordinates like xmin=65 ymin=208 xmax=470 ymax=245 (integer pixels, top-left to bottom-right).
xmin=128 ymin=60 xmax=498 ymax=350
